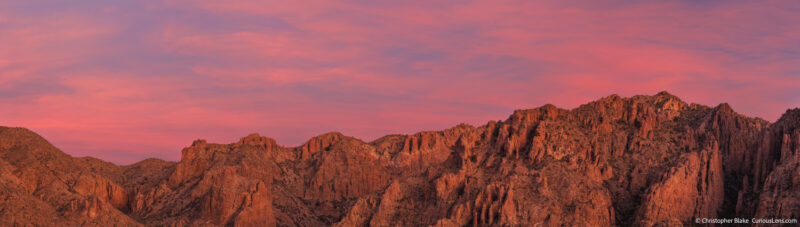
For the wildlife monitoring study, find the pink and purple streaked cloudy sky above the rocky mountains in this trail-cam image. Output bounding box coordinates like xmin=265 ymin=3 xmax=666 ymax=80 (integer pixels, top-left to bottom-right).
xmin=0 ymin=0 xmax=800 ymax=164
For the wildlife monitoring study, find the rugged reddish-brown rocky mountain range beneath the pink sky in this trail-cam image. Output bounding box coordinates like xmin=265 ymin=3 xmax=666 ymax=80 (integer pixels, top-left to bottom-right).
xmin=0 ymin=92 xmax=800 ymax=226
